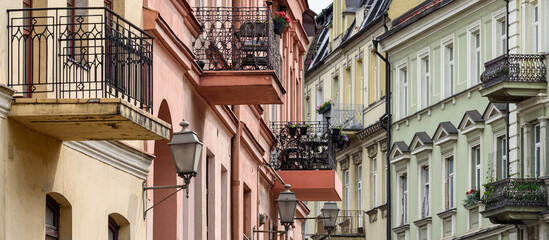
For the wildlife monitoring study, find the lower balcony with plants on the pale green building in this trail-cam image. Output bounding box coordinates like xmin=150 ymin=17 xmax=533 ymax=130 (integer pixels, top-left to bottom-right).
xmin=481 ymin=178 xmax=548 ymax=224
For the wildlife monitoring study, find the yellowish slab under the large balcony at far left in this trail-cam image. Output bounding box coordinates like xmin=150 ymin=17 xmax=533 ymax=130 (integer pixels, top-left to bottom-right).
xmin=9 ymin=98 xmax=171 ymax=141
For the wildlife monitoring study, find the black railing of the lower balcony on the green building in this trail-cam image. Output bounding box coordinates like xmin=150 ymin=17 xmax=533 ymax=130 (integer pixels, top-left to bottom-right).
xmin=482 ymin=178 xmax=547 ymax=210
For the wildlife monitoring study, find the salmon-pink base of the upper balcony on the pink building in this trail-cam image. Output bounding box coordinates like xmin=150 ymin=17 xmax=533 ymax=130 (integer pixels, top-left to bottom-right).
xmin=198 ymin=70 xmax=286 ymax=105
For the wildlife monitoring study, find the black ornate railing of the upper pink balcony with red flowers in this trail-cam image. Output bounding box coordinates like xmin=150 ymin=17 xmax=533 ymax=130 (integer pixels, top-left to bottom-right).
xmin=193 ymin=7 xmax=281 ymax=79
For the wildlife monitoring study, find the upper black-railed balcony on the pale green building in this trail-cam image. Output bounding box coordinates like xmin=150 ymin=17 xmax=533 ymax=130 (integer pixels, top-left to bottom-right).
xmin=480 ymin=54 xmax=547 ymax=102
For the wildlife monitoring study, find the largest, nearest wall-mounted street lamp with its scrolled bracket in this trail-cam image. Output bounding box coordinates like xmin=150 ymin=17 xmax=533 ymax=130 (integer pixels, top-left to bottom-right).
xmin=143 ymin=121 xmax=202 ymax=217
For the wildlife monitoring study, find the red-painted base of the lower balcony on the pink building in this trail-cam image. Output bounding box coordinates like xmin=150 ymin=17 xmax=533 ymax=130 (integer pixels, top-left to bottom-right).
xmin=273 ymin=170 xmax=342 ymax=201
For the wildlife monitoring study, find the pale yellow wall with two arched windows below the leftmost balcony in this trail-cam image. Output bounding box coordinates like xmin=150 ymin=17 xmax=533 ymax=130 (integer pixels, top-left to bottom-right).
xmin=4 ymin=120 xmax=146 ymax=240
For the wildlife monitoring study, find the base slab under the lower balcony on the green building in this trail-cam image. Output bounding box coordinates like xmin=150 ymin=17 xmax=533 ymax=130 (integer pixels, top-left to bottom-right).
xmin=481 ymin=206 xmax=547 ymax=224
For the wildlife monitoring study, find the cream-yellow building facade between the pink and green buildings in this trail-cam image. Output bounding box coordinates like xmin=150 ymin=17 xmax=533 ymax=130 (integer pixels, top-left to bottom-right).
xmin=303 ymin=0 xmax=392 ymax=239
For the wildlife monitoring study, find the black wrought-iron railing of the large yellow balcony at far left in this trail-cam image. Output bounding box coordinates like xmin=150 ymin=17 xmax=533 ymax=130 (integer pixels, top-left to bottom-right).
xmin=8 ymin=7 xmax=153 ymax=111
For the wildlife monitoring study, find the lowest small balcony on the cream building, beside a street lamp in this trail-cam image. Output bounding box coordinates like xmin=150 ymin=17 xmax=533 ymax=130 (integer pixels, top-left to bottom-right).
xmin=312 ymin=210 xmax=366 ymax=240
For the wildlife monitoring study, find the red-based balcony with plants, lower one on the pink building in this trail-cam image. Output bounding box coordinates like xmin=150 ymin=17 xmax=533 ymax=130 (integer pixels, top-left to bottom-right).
xmin=271 ymin=122 xmax=342 ymax=201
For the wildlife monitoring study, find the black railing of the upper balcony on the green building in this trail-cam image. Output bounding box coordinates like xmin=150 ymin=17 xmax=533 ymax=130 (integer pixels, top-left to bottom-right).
xmin=480 ymin=54 xmax=546 ymax=87
